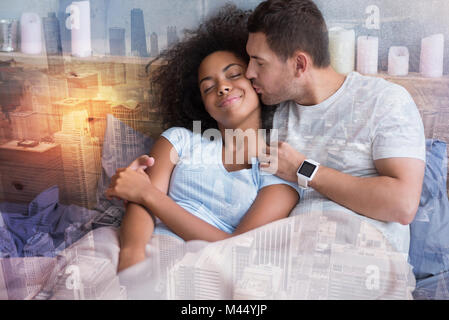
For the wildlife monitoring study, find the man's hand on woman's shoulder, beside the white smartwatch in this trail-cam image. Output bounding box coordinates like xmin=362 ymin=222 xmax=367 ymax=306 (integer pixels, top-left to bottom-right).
xmin=259 ymin=141 xmax=306 ymax=182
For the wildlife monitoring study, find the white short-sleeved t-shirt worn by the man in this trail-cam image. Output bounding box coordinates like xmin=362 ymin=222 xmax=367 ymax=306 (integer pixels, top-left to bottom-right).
xmin=272 ymin=72 xmax=425 ymax=253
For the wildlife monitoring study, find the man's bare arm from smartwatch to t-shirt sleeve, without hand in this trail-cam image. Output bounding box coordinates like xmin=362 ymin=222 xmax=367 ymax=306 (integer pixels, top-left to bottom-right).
xmin=309 ymin=158 xmax=425 ymax=225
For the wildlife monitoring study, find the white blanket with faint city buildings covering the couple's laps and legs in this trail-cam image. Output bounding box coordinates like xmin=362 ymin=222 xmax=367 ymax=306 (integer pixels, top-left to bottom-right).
xmin=0 ymin=212 xmax=415 ymax=300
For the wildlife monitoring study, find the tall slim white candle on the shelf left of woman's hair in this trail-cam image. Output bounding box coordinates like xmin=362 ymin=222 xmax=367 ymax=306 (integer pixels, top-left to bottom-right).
xmin=71 ymin=1 xmax=92 ymax=57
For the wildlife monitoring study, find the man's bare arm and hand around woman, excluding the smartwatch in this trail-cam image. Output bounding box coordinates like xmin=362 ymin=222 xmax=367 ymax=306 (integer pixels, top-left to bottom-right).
xmin=258 ymin=142 xmax=425 ymax=225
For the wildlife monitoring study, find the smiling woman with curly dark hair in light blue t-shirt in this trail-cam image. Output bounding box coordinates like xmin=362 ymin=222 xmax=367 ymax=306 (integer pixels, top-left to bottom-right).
xmin=106 ymin=6 xmax=299 ymax=271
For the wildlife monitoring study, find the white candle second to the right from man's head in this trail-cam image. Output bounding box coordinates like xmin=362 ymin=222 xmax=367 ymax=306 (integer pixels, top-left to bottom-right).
xmin=357 ymin=36 xmax=379 ymax=74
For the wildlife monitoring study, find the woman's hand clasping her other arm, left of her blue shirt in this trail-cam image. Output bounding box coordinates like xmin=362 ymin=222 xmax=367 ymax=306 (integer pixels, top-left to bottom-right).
xmin=105 ymin=167 xmax=153 ymax=204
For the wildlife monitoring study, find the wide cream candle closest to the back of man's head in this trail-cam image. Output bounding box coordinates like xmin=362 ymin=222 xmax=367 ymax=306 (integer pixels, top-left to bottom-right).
xmin=329 ymin=27 xmax=355 ymax=74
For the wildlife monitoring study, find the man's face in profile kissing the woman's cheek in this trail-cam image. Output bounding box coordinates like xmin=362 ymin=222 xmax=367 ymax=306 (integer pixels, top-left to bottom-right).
xmin=246 ymin=32 xmax=295 ymax=105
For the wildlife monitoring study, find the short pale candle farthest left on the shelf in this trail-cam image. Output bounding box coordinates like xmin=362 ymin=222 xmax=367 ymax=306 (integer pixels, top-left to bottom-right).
xmin=20 ymin=12 xmax=42 ymax=54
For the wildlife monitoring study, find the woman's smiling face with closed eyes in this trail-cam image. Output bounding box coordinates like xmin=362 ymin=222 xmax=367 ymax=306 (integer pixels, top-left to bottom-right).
xmin=198 ymin=51 xmax=260 ymax=128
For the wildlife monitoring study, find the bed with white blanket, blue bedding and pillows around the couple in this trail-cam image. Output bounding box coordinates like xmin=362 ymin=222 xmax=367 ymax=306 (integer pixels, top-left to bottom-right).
xmin=0 ymin=109 xmax=449 ymax=300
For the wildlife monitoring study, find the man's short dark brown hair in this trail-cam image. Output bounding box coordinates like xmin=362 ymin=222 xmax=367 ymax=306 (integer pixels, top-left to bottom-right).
xmin=248 ymin=0 xmax=330 ymax=68
